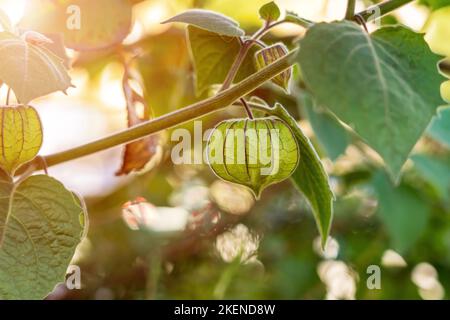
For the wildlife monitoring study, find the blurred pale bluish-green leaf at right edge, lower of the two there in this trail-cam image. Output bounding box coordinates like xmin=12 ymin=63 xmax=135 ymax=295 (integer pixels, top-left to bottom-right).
xmin=411 ymin=154 xmax=450 ymax=201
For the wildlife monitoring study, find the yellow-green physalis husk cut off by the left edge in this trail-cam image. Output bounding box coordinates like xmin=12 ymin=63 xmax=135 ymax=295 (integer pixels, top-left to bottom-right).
xmin=0 ymin=106 xmax=42 ymax=174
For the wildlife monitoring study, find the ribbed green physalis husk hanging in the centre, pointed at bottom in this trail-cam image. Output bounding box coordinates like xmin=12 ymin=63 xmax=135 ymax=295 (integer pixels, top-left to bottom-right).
xmin=207 ymin=117 xmax=299 ymax=199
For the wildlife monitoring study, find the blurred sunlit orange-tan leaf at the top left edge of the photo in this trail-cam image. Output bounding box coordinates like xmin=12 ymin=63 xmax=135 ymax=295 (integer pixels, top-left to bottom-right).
xmin=20 ymin=0 xmax=132 ymax=50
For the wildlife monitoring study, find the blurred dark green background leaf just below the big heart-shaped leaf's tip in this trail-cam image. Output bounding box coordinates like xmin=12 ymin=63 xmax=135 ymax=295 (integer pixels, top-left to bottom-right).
xmin=372 ymin=172 xmax=430 ymax=253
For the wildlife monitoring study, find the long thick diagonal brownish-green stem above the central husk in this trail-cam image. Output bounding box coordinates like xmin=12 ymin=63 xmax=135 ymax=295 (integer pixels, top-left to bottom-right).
xmin=37 ymin=49 xmax=298 ymax=170
